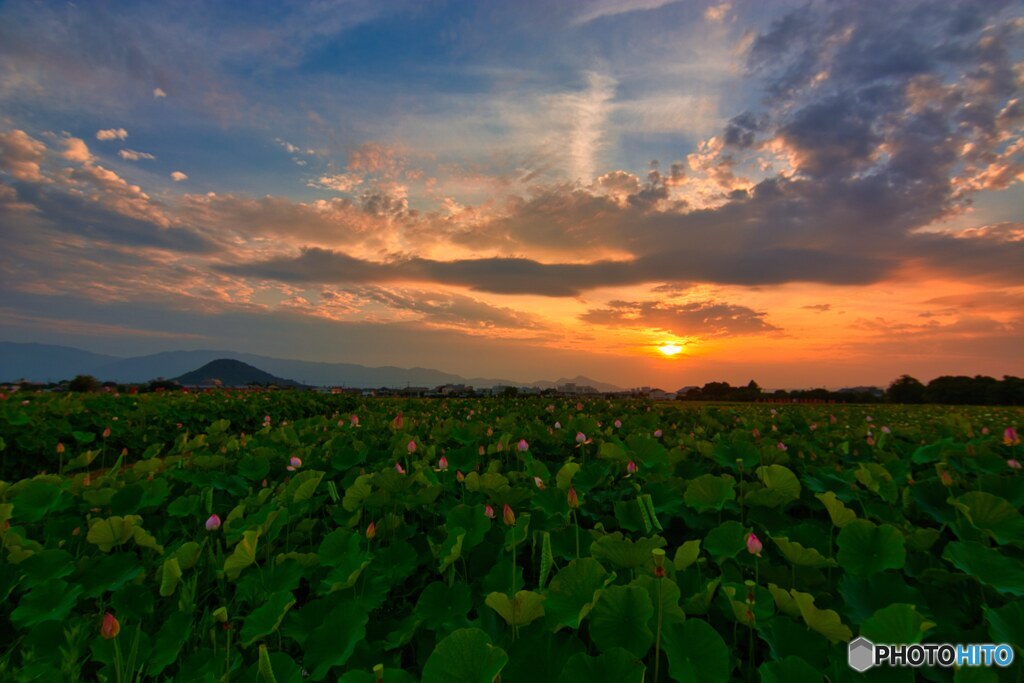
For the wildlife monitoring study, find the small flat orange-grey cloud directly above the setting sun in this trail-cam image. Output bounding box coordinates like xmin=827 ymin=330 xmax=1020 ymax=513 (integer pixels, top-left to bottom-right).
xmin=580 ymin=301 xmax=778 ymax=337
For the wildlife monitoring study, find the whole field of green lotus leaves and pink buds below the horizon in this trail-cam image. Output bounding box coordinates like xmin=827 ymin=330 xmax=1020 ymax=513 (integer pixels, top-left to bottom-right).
xmin=0 ymin=391 xmax=1024 ymax=683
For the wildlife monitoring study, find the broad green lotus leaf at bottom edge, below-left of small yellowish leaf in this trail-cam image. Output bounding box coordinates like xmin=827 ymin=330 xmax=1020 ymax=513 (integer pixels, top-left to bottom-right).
xmin=422 ymin=629 xmax=509 ymax=683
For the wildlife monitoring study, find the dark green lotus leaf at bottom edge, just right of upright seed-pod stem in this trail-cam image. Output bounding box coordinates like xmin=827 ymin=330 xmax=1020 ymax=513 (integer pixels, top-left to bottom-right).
xmin=662 ymin=618 xmax=732 ymax=683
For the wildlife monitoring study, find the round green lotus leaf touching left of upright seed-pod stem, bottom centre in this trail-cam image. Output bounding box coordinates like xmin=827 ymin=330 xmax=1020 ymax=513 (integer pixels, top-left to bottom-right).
xmin=590 ymin=586 xmax=654 ymax=658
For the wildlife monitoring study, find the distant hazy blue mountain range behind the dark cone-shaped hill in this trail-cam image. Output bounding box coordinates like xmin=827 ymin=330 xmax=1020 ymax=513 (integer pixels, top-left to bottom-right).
xmin=0 ymin=342 xmax=620 ymax=391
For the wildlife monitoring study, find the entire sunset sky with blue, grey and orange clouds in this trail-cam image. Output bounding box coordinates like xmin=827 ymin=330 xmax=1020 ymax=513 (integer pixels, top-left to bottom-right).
xmin=0 ymin=0 xmax=1024 ymax=390
